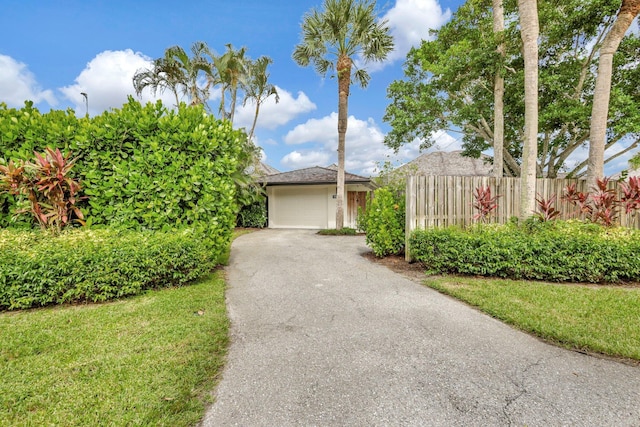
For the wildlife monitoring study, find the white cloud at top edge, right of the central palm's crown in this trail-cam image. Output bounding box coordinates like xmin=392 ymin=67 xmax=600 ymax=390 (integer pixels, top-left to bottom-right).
xmin=357 ymin=0 xmax=451 ymax=71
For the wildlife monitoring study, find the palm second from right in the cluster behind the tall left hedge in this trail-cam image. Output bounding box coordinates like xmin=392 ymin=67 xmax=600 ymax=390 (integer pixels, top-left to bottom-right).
xmin=212 ymin=44 xmax=247 ymax=123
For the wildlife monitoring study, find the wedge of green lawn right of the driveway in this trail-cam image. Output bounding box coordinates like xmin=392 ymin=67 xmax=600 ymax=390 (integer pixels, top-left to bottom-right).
xmin=425 ymin=277 xmax=640 ymax=360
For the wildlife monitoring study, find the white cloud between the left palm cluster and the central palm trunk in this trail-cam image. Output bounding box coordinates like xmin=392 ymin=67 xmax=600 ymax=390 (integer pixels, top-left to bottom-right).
xmin=234 ymin=86 xmax=316 ymax=129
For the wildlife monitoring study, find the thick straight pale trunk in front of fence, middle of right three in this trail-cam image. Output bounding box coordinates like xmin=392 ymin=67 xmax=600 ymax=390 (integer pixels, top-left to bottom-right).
xmin=518 ymin=0 xmax=540 ymax=220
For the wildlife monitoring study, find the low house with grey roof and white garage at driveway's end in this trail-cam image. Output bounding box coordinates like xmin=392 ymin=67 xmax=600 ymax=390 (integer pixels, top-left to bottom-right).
xmin=260 ymin=166 xmax=373 ymax=229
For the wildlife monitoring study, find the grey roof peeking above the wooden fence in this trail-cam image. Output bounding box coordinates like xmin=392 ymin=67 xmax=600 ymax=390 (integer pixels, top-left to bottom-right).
xmin=396 ymin=150 xmax=493 ymax=176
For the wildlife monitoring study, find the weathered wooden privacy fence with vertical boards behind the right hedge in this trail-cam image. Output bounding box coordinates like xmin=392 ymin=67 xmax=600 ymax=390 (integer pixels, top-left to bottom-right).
xmin=405 ymin=176 xmax=639 ymax=255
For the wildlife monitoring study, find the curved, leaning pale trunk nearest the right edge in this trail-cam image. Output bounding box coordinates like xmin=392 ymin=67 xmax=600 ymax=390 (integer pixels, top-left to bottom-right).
xmin=587 ymin=0 xmax=640 ymax=185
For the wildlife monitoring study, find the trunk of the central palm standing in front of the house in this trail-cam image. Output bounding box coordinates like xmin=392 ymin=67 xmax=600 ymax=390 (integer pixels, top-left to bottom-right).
xmin=336 ymin=56 xmax=351 ymax=230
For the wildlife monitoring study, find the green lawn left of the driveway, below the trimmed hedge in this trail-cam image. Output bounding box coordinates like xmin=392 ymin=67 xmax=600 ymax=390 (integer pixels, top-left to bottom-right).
xmin=0 ymin=271 xmax=229 ymax=426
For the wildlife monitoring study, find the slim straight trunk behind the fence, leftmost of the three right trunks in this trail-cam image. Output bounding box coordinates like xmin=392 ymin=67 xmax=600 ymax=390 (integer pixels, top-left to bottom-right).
xmin=493 ymin=0 xmax=505 ymax=178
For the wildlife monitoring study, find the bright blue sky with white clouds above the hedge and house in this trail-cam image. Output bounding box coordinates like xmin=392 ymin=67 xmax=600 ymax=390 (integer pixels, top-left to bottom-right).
xmin=0 ymin=0 xmax=636 ymax=175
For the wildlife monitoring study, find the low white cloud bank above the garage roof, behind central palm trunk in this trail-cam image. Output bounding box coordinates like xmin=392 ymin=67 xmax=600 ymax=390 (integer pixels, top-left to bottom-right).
xmin=281 ymin=112 xmax=456 ymax=176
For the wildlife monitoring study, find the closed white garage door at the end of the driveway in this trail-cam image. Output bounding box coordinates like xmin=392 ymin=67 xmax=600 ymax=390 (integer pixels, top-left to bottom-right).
xmin=269 ymin=187 xmax=329 ymax=228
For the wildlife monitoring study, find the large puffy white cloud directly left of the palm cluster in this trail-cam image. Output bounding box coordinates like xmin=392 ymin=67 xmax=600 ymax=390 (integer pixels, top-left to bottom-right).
xmin=60 ymin=49 xmax=175 ymax=114
